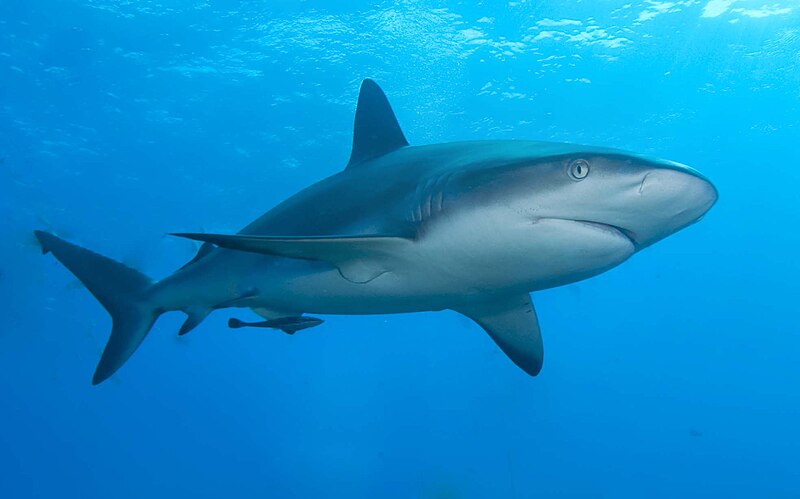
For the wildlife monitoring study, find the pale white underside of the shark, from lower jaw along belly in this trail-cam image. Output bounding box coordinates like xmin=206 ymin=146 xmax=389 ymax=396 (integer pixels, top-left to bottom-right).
xmin=253 ymin=209 xmax=634 ymax=314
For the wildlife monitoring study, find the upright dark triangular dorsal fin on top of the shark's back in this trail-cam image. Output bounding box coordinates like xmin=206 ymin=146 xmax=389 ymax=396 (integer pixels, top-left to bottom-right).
xmin=347 ymin=79 xmax=408 ymax=168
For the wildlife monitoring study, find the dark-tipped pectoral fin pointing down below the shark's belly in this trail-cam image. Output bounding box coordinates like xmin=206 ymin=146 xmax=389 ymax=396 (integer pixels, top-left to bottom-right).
xmin=456 ymin=294 xmax=544 ymax=376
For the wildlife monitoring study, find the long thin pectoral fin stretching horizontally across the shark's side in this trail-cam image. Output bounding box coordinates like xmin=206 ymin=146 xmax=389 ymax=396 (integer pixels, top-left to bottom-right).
xmin=173 ymin=233 xmax=414 ymax=283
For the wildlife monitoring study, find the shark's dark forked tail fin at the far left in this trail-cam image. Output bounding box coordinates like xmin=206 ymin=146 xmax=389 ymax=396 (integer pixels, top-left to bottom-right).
xmin=34 ymin=230 xmax=161 ymax=385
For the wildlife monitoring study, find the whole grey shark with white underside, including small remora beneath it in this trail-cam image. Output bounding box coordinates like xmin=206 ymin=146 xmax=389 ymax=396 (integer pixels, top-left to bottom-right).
xmin=35 ymin=80 xmax=717 ymax=384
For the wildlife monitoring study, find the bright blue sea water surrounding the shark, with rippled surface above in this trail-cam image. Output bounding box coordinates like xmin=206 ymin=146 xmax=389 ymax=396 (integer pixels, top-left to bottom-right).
xmin=0 ymin=0 xmax=800 ymax=498
